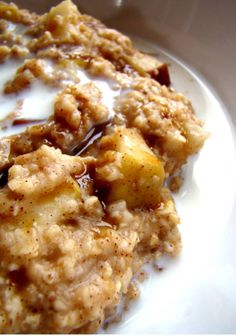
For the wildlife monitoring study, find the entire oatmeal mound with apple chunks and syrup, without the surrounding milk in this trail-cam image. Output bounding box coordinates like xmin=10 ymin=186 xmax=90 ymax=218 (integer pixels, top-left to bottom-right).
xmin=0 ymin=1 xmax=206 ymax=333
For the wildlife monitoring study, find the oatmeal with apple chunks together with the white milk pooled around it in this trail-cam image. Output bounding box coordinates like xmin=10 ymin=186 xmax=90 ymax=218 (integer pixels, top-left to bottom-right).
xmin=0 ymin=0 xmax=234 ymax=333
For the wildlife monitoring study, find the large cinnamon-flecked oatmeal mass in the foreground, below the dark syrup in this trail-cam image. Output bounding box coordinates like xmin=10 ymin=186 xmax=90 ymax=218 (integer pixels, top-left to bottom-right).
xmin=0 ymin=145 xmax=180 ymax=333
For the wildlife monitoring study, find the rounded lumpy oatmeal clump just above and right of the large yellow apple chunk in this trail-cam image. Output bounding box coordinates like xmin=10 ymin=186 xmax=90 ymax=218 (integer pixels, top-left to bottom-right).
xmin=114 ymin=78 xmax=206 ymax=174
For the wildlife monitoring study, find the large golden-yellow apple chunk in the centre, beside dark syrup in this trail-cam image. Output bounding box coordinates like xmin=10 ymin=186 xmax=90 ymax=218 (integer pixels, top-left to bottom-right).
xmin=97 ymin=128 xmax=165 ymax=208
